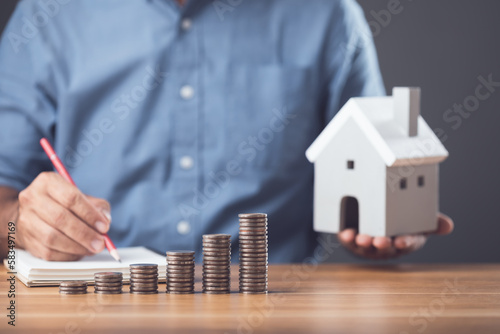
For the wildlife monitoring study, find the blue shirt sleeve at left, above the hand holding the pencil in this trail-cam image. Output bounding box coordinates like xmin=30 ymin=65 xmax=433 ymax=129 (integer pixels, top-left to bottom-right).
xmin=0 ymin=1 xmax=55 ymax=190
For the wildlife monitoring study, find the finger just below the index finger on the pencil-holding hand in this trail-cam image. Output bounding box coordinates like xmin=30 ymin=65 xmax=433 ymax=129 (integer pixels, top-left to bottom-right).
xmin=32 ymin=199 xmax=104 ymax=253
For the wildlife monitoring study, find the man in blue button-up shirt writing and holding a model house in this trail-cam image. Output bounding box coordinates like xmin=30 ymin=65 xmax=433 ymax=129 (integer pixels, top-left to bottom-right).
xmin=0 ymin=0 xmax=453 ymax=262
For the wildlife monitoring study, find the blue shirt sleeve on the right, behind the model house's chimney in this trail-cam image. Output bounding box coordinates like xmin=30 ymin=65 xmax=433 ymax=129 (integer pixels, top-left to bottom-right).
xmin=326 ymin=0 xmax=386 ymax=122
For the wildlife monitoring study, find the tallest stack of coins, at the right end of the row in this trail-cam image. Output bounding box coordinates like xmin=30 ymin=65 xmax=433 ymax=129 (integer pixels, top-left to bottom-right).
xmin=238 ymin=213 xmax=267 ymax=294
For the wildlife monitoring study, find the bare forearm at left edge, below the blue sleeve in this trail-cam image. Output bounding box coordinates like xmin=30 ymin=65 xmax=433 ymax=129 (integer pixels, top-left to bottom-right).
xmin=0 ymin=186 xmax=19 ymax=259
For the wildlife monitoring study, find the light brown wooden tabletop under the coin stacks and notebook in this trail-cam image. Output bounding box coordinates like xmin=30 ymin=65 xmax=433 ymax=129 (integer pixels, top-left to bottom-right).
xmin=0 ymin=264 xmax=500 ymax=334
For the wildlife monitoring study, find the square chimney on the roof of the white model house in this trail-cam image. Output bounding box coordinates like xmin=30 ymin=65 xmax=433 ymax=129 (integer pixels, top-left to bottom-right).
xmin=392 ymin=87 xmax=420 ymax=137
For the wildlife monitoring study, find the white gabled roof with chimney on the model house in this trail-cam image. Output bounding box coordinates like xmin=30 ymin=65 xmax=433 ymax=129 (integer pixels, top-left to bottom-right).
xmin=306 ymin=88 xmax=448 ymax=167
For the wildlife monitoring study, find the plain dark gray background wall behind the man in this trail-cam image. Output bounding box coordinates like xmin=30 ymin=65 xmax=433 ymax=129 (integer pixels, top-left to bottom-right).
xmin=0 ymin=0 xmax=500 ymax=262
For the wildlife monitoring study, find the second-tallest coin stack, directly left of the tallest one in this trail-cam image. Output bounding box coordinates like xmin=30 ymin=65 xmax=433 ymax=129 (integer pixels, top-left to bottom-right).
xmin=203 ymin=234 xmax=231 ymax=294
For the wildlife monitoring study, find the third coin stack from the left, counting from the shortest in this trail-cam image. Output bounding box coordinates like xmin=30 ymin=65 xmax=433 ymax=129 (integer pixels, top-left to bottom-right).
xmin=130 ymin=263 xmax=158 ymax=295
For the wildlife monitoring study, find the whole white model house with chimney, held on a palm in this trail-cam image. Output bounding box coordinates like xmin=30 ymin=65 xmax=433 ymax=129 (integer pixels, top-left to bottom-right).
xmin=306 ymin=87 xmax=448 ymax=236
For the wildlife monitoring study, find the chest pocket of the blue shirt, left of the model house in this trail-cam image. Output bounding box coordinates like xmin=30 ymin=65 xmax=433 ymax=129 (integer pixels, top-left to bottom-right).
xmin=224 ymin=65 xmax=321 ymax=171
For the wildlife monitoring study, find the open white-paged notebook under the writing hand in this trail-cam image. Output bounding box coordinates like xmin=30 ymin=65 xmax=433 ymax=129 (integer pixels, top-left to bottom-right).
xmin=5 ymin=247 xmax=166 ymax=287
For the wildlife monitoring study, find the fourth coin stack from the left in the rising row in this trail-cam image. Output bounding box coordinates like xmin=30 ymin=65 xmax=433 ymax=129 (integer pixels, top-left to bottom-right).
xmin=167 ymin=251 xmax=194 ymax=294
